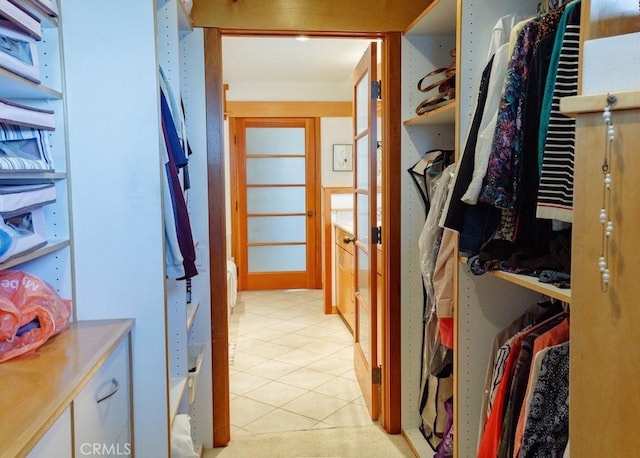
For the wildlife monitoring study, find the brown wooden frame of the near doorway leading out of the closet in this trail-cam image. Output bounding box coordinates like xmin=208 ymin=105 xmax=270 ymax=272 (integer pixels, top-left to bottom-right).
xmin=204 ymin=28 xmax=403 ymax=447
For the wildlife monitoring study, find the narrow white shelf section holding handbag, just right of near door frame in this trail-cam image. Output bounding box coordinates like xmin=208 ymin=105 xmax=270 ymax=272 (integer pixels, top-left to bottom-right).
xmin=401 ymin=0 xmax=458 ymax=450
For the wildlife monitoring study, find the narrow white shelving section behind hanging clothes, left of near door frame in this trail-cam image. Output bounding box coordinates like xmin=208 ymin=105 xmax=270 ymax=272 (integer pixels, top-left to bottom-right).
xmin=156 ymin=0 xmax=213 ymax=447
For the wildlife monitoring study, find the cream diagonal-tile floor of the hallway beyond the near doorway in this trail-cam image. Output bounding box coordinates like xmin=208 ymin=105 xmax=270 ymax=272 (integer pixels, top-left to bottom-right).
xmin=229 ymin=290 xmax=373 ymax=438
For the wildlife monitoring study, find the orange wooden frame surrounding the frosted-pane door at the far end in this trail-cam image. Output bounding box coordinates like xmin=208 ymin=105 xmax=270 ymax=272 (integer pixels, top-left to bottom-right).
xmin=228 ymin=116 xmax=322 ymax=290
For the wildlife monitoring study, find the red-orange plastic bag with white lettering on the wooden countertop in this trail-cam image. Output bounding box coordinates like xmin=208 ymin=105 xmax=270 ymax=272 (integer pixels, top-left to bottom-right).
xmin=0 ymin=270 xmax=71 ymax=362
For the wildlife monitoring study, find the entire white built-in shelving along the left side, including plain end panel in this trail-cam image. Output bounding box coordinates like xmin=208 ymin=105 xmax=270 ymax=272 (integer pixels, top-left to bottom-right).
xmin=0 ymin=0 xmax=213 ymax=457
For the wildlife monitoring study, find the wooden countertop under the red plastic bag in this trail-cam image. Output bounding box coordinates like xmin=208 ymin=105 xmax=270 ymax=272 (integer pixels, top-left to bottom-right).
xmin=0 ymin=319 xmax=133 ymax=457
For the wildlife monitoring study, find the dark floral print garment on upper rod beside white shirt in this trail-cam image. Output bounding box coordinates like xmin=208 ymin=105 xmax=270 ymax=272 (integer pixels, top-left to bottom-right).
xmin=480 ymin=18 xmax=540 ymax=210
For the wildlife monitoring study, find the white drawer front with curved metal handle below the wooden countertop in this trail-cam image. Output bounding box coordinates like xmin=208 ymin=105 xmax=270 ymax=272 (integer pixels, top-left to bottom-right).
xmin=73 ymin=338 xmax=131 ymax=456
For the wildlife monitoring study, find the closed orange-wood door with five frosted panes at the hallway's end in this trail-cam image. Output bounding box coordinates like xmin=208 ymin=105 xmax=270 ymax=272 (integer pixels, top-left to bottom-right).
xmin=229 ymin=118 xmax=322 ymax=291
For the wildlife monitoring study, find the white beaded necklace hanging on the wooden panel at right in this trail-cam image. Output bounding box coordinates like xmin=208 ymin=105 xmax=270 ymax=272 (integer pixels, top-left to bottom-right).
xmin=598 ymin=94 xmax=617 ymax=292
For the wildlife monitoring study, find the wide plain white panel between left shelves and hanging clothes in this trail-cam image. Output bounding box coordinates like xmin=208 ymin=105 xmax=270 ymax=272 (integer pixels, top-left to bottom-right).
xmin=61 ymin=0 xmax=169 ymax=457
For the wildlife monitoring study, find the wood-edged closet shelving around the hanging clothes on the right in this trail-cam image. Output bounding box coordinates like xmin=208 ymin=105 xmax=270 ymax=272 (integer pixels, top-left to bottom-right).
xmin=402 ymin=0 xmax=571 ymax=458
